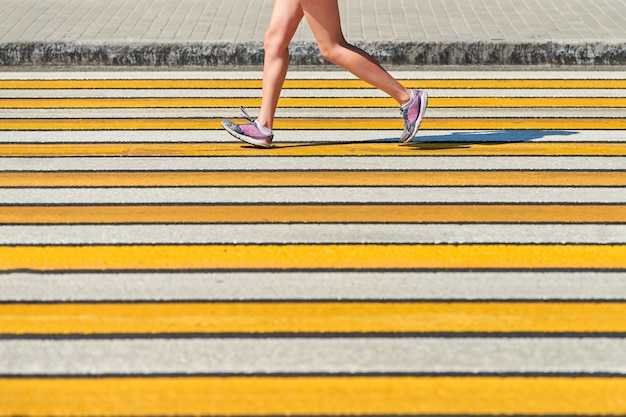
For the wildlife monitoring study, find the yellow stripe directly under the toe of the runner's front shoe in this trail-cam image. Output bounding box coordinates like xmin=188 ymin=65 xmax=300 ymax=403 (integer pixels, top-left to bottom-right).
xmin=0 ymin=142 xmax=626 ymax=157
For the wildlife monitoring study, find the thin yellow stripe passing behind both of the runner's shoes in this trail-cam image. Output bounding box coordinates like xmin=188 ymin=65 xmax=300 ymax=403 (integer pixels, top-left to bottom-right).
xmin=0 ymin=117 xmax=626 ymax=130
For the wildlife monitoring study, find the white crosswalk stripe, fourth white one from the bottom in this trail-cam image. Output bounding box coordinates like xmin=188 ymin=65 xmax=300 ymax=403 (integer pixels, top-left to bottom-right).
xmin=0 ymin=187 xmax=626 ymax=204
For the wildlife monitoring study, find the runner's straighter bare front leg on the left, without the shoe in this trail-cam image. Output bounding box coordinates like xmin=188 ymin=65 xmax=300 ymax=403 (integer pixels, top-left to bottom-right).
xmin=256 ymin=0 xmax=304 ymax=129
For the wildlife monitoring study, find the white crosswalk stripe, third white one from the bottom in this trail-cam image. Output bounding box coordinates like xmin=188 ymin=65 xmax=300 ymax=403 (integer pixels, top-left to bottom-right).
xmin=0 ymin=223 xmax=626 ymax=245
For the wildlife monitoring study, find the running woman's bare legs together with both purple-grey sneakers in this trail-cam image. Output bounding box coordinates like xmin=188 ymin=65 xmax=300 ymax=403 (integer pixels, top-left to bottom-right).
xmin=222 ymin=0 xmax=428 ymax=148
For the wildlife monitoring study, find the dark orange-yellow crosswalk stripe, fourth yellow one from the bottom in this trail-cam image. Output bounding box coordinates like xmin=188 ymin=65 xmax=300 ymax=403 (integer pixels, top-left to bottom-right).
xmin=0 ymin=205 xmax=626 ymax=224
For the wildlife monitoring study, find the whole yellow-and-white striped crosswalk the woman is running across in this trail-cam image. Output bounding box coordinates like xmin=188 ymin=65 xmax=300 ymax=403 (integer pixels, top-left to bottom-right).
xmin=0 ymin=71 xmax=626 ymax=417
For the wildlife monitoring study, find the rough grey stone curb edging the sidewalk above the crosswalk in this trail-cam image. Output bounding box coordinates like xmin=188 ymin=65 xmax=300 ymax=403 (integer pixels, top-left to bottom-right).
xmin=0 ymin=41 xmax=626 ymax=68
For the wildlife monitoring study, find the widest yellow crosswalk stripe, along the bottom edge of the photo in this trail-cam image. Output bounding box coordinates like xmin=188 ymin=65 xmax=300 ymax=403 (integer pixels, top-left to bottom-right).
xmin=0 ymin=376 xmax=626 ymax=417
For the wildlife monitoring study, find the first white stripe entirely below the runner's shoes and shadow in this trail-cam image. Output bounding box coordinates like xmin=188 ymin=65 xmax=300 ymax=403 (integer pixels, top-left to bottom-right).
xmin=0 ymin=156 xmax=625 ymax=172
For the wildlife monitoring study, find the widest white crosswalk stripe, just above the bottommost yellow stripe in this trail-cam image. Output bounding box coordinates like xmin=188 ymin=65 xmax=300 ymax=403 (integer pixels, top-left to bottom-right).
xmin=0 ymin=338 xmax=626 ymax=375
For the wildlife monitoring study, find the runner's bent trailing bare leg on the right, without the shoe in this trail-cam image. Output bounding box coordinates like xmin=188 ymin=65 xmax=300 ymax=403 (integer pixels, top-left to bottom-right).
xmin=300 ymin=0 xmax=411 ymax=105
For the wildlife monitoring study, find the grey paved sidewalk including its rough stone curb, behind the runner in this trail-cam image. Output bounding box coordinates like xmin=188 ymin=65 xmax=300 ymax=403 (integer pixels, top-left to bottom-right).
xmin=0 ymin=0 xmax=626 ymax=67
